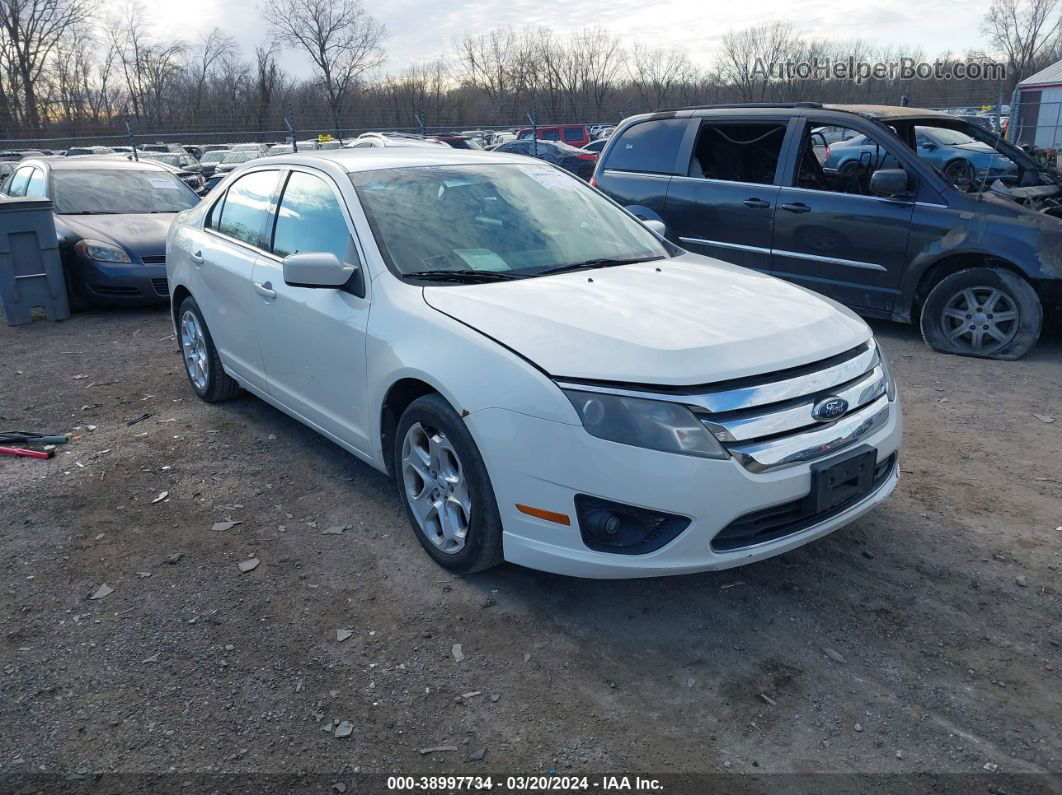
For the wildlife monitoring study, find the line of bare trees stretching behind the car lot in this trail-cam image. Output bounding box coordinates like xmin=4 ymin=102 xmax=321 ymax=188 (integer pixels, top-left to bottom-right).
xmin=0 ymin=0 xmax=1062 ymax=139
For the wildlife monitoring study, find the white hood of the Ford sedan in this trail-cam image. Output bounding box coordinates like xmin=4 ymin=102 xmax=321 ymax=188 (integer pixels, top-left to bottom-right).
xmin=424 ymin=254 xmax=871 ymax=386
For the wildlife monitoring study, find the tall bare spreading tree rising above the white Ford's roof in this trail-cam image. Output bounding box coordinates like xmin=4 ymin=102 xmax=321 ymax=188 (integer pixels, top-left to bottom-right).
xmin=259 ymin=0 xmax=387 ymax=129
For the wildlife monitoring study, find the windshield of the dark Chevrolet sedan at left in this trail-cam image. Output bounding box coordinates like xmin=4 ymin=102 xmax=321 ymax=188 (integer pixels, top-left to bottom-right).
xmin=52 ymin=169 xmax=199 ymax=215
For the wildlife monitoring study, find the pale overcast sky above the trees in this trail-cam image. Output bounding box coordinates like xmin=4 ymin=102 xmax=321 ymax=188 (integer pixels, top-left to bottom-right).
xmin=144 ymin=0 xmax=989 ymax=76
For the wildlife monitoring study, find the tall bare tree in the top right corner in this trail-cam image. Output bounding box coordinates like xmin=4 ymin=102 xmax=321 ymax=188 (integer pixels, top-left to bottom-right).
xmin=981 ymin=0 xmax=1062 ymax=89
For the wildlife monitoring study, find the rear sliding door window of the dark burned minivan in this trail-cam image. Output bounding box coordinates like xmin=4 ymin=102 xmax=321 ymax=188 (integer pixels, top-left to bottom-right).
xmin=687 ymin=121 xmax=786 ymax=185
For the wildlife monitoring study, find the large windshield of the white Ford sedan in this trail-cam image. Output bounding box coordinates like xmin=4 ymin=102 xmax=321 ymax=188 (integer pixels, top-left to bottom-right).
xmin=350 ymin=163 xmax=668 ymax=277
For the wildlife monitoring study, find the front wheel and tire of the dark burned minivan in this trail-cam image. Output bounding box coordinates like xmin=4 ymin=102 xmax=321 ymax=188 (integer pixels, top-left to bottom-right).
xmin=920 ymin=267 xmax=1044 ymax=361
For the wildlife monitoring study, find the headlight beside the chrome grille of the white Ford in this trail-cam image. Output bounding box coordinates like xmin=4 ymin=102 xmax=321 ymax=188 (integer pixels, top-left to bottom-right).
xmin=562 ymin=390 xmax=730 ymax=459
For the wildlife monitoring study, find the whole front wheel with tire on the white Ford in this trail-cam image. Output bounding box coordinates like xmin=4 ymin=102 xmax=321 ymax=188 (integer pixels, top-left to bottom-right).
xmin=394 ymin=393 xmax=502 ymax=574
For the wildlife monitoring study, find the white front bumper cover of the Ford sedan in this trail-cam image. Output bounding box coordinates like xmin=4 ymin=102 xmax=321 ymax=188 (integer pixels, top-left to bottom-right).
xmin=466 ymin=401 xmax=903 ymax=578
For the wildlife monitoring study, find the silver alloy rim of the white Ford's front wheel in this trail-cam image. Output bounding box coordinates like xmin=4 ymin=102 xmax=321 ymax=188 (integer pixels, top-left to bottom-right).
xmin=401 ymin=422 xmax=472 ymax=554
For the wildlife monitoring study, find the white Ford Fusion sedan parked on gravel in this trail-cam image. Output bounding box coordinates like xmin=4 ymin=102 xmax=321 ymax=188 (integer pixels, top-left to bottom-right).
xmin=166 ymin=148 xmax=901 ymax=577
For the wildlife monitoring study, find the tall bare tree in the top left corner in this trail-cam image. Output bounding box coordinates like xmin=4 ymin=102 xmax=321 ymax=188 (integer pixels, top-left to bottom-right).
xmin=0 ymin=0 xmax=96 ymax=133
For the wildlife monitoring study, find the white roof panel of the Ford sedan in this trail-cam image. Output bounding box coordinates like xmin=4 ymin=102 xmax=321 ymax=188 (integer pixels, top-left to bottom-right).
xmin=248 ymin=146 xmax=531 ymax=173
